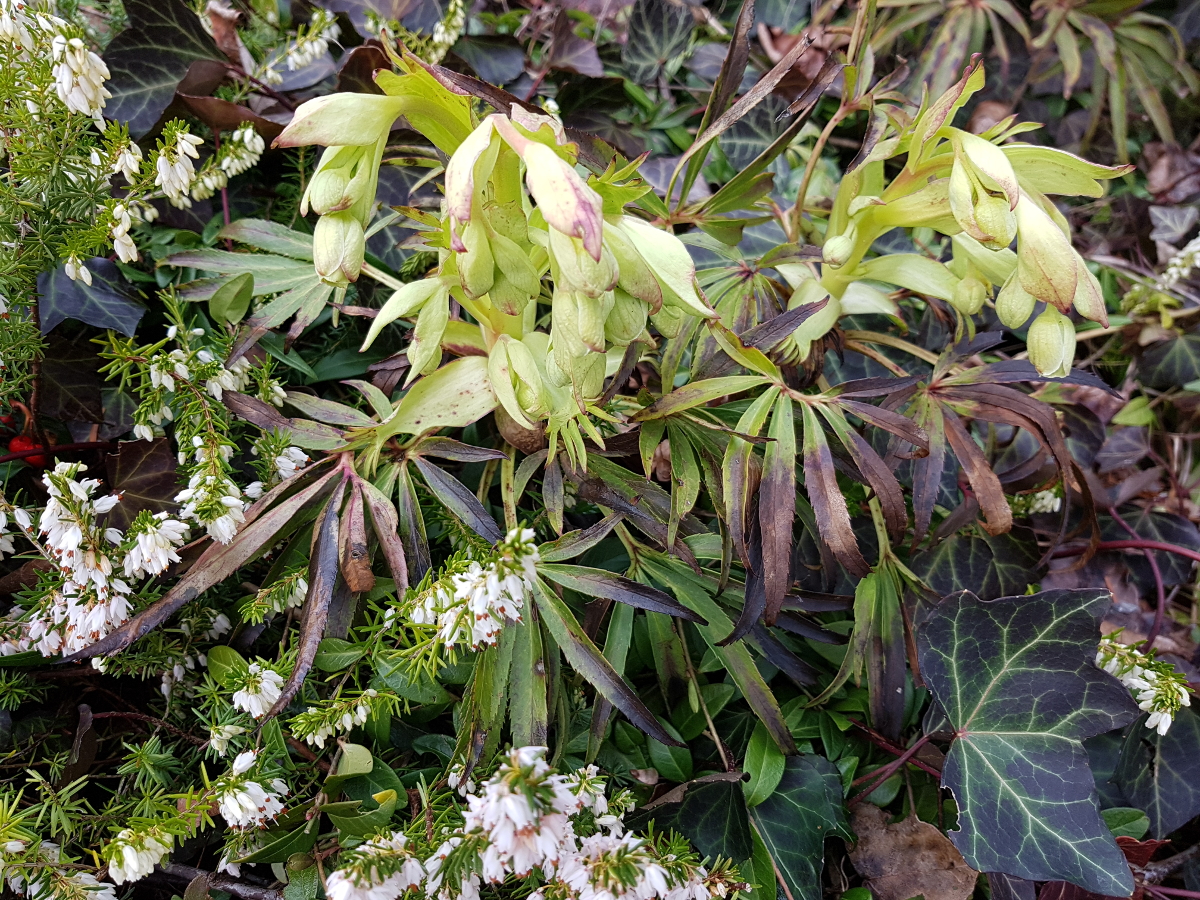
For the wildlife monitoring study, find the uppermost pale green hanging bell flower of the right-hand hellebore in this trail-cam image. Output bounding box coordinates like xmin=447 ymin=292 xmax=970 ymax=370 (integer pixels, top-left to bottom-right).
xmin=949 ymin=128 xmax=1021 ymax=250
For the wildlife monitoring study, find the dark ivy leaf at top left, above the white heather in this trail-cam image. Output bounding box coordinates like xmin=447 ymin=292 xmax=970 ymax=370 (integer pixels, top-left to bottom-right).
xmin=104 ymin=0 xmax=223 ymax=138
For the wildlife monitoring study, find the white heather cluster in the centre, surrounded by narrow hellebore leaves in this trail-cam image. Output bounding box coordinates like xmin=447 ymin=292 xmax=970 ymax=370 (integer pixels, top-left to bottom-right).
xmin=409 ymin=528 xmax=539 ymax=649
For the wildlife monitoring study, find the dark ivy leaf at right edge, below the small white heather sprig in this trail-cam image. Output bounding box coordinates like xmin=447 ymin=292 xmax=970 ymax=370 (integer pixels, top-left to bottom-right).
xmin=1112 ymin=708 xmax=1200 ymax=838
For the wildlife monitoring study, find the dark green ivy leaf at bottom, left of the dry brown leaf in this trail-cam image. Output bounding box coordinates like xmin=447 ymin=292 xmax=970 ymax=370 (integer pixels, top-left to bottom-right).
xmin=750 ymin=755 xmax=850 ymax=900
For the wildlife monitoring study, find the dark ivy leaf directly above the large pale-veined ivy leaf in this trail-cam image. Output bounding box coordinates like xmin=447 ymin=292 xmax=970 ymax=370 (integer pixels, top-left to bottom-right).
xmin=912 ymin=528 xmax=1042 ymax=600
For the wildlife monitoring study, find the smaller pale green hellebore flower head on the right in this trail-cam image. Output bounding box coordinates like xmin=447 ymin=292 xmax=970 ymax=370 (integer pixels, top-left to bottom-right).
xmin=781 ymin=65 xmax=1129 ymax=377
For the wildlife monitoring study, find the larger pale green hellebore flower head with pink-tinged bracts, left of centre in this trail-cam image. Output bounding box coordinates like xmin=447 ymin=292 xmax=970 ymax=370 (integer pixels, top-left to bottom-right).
xmin=276 ymin=54 xmax=715 ymax=460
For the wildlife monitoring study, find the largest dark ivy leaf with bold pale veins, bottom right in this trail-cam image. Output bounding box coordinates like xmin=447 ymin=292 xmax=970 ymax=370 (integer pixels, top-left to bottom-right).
xmin=918 ymin=590 xmax=1138 ymax=896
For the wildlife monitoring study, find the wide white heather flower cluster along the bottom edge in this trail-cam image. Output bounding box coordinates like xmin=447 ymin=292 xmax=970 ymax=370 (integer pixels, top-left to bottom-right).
xmin=328 ymin=746 xmax=730 ymax=900
